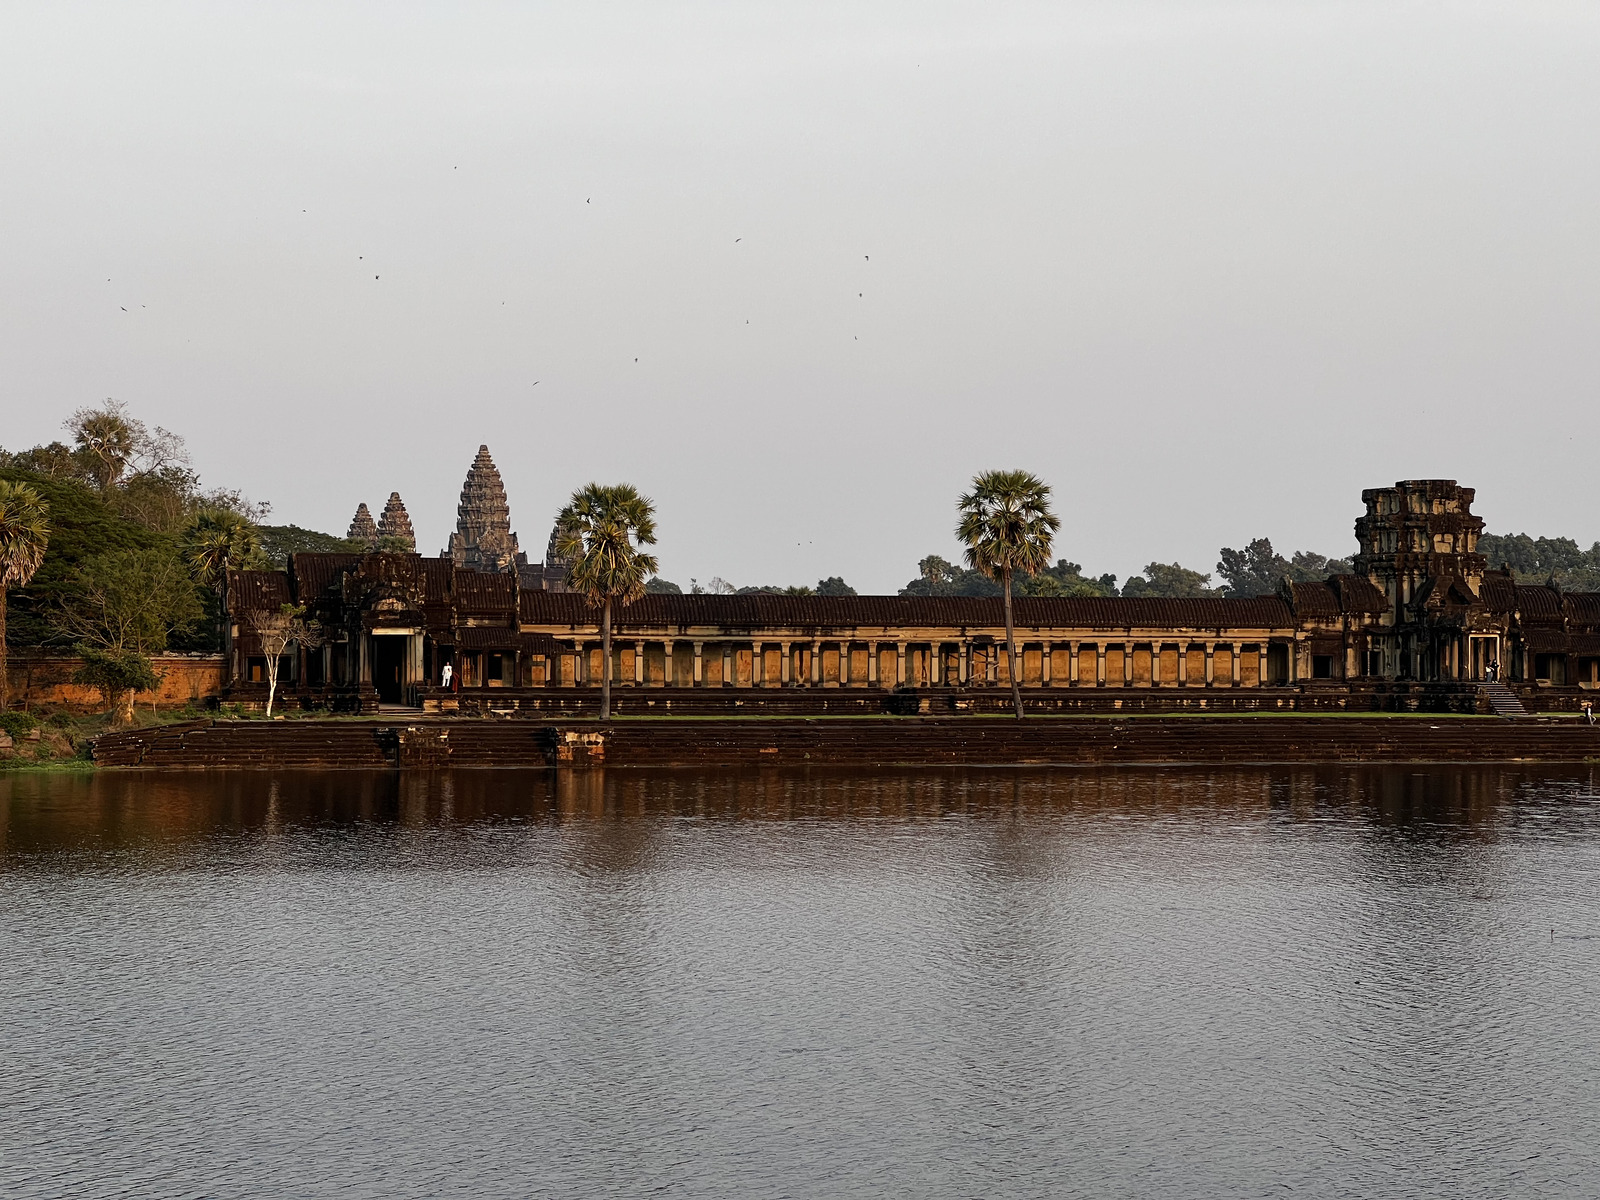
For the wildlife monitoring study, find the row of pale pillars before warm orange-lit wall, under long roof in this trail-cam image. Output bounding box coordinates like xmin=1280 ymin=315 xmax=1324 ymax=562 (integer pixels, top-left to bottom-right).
xmin=549 ymin=637 xmax=1301 ymax=688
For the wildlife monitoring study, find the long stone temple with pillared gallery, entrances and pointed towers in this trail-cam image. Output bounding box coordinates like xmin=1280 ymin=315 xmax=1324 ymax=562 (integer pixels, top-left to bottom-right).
xmin=226 ymin=464 xmax=1600 ymax=712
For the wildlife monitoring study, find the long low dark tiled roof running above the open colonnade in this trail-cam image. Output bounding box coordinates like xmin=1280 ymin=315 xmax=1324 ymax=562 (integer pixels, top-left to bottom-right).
xmin=522 ymin=592 xmax=1294 ymax=630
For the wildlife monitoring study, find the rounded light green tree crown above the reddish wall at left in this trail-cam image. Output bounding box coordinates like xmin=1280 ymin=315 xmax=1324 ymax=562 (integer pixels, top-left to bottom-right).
xmin=56 ymin=546 xmax=202 ymax=654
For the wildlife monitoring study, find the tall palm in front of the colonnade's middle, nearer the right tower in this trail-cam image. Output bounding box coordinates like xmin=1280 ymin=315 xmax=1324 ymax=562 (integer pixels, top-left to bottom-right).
xmin=955 ymin=470 xmax=1061 ymax=720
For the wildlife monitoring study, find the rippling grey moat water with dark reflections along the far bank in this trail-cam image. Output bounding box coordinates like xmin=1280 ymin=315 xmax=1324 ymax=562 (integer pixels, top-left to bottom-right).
xmin=0 ymin=768 xmax=1600 ymax=1198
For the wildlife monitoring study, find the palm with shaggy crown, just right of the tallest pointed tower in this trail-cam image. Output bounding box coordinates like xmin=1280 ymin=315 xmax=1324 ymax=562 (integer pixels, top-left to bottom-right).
xmin=555 ymin=483 xmax=658 ymax=720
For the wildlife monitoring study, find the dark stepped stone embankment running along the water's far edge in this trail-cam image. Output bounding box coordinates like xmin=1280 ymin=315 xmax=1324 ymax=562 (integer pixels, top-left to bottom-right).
xmin=94 ymin=717 xmax=1600 ymax=770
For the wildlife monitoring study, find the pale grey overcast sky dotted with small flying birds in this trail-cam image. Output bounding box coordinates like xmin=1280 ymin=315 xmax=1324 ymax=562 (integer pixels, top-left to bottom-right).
xmin=0 ymin=0 xmax=1600 ymax=592
